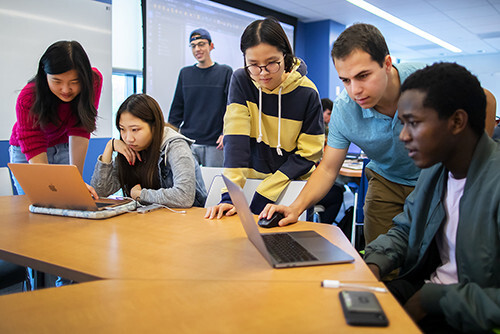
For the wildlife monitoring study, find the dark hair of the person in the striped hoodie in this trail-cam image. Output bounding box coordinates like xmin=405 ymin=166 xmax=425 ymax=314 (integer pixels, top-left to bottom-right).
xmin=240 ymin=17 xmax=295 ymax=72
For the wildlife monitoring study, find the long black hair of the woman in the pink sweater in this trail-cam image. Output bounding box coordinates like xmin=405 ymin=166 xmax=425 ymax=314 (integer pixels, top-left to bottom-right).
xmin=31 ymin=41 xmax=99 ymax=133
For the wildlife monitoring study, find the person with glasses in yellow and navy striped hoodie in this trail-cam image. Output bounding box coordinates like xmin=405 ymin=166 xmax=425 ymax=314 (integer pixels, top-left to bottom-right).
xmin=206 ymin=18 xmax=324 ymax=218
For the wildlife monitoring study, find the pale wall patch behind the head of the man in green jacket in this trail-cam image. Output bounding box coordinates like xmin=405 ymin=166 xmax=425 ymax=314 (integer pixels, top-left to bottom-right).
xmin=412 ymin=53 xmax=500 ymax=116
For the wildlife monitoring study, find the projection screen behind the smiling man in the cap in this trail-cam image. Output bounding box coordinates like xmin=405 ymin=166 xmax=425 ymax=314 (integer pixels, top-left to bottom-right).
xmin=144 ymin=0 xmax=294 ymax=119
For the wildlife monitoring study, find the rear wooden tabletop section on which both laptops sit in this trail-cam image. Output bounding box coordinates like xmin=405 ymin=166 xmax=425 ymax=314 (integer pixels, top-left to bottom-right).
xmin=0 ymin=196 xmax=376 ymax=284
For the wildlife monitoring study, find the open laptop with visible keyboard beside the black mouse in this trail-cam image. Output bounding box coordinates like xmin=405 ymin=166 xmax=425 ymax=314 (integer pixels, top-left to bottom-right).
xmin=222 ymin=175 xmax=354 ymax=268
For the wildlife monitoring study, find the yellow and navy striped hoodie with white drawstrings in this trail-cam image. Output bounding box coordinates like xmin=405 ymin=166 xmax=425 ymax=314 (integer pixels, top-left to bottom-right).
xmin=221 ymin=59 xmax=324 ymax=214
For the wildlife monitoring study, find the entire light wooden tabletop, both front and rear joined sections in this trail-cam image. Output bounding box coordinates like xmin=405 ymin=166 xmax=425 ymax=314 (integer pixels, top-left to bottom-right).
xmin=0 ymin=196 xmax=418 ymax=333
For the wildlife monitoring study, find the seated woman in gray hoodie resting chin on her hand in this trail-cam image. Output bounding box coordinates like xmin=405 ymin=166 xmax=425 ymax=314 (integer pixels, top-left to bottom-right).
xmin=91 ymin=94 xmax=207 ymax=208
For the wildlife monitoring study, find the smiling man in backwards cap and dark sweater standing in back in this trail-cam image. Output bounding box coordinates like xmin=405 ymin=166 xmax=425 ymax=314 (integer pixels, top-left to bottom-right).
xmin=168 ymin=28 xmax=233 ymax=167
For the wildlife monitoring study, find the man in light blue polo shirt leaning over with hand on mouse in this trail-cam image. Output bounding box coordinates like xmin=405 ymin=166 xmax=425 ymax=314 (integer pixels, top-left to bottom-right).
xmin=261 ymin=24 xmax=425 ymax=243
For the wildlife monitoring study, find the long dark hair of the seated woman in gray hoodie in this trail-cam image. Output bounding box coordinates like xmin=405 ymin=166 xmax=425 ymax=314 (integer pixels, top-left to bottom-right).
xmin=116 ymin=94 xmax=165 ymax=196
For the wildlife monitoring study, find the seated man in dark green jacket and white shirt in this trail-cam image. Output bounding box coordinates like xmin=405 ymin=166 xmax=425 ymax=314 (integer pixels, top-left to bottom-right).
xmin=365 ymin=63 xmax=500 ymax=333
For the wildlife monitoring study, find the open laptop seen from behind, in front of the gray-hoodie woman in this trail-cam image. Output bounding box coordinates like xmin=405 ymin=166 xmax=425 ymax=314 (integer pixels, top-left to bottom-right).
xmin=8 ymin=163 xmax=135 ymax=218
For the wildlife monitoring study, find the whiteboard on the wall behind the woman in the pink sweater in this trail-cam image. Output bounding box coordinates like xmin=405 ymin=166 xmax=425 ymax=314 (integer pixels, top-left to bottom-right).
xmin=0 ymin=0 xmax=113 ymax=140
